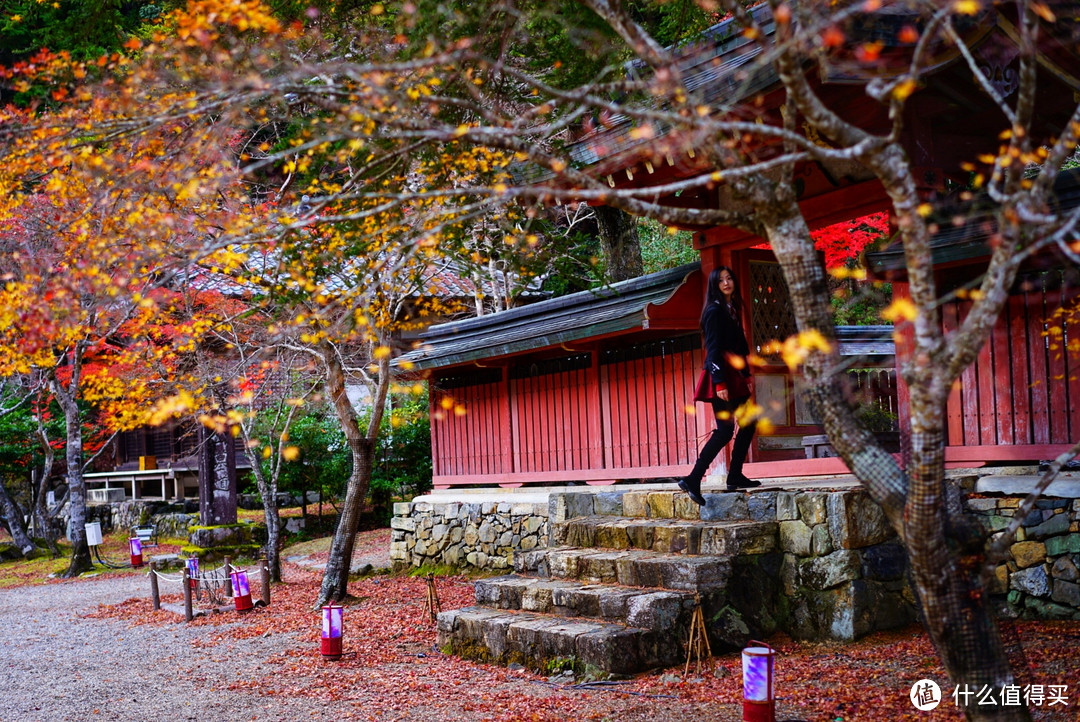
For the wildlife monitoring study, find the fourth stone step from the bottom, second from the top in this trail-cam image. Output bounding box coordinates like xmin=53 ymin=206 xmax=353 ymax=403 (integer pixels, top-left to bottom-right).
xmin=550 ymin=516 xmax=778 ymax=557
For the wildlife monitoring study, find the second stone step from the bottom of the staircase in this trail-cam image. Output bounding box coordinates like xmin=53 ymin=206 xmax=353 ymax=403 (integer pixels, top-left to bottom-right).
xmin=475 ymin=574 xmax=697 ymax=631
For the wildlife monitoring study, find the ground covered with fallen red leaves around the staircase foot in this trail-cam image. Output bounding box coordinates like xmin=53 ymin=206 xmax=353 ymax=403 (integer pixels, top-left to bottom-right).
xmin=71 ymin=531 xmax=1080 ymax=722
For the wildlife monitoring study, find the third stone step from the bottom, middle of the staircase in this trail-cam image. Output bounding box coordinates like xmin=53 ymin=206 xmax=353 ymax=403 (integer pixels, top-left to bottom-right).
xmin=514 ymin=547 xmax=731 ymax=594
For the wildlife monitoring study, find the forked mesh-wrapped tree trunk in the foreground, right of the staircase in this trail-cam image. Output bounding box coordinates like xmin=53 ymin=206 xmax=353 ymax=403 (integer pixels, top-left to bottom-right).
xmin=760 ymin=190 xmax=1030 ymax=720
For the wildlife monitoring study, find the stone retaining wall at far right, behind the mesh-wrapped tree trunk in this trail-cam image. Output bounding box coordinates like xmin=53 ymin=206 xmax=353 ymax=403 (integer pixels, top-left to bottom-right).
xmin=968 ymin=494 xmax=1080 ymax=619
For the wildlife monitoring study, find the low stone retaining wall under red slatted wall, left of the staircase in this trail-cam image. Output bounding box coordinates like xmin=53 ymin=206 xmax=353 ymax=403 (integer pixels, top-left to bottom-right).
xmin=390 ymin=502 xmax=548 ymax=570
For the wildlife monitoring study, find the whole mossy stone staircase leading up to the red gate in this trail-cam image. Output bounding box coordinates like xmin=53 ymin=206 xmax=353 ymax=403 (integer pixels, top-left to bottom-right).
xmin=438 ymin=490 xmax=781 ymax=673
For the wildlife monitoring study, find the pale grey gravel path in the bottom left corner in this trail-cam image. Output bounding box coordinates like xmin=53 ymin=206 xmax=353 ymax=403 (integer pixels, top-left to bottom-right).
xmin=0 ymin=576 xmax=336 ymax=722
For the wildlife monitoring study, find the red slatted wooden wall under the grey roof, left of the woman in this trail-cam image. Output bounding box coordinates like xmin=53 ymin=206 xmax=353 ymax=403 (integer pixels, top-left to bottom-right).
xmin=431 ymin=335 xmax=712 ymax=486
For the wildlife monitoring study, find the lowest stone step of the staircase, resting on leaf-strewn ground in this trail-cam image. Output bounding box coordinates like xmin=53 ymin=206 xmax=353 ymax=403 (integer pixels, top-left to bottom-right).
xmin=437 ymin=607 xmax=684 ymax=675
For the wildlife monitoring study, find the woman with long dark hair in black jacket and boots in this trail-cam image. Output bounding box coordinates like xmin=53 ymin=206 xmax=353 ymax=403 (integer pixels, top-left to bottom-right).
xmin=678 ymin=265 xmax=761 ymax=506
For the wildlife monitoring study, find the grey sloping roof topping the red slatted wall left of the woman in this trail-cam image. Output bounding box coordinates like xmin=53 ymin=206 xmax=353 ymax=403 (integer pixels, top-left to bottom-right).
xmin=395 ymin=263 xmax=699 ymax=370
